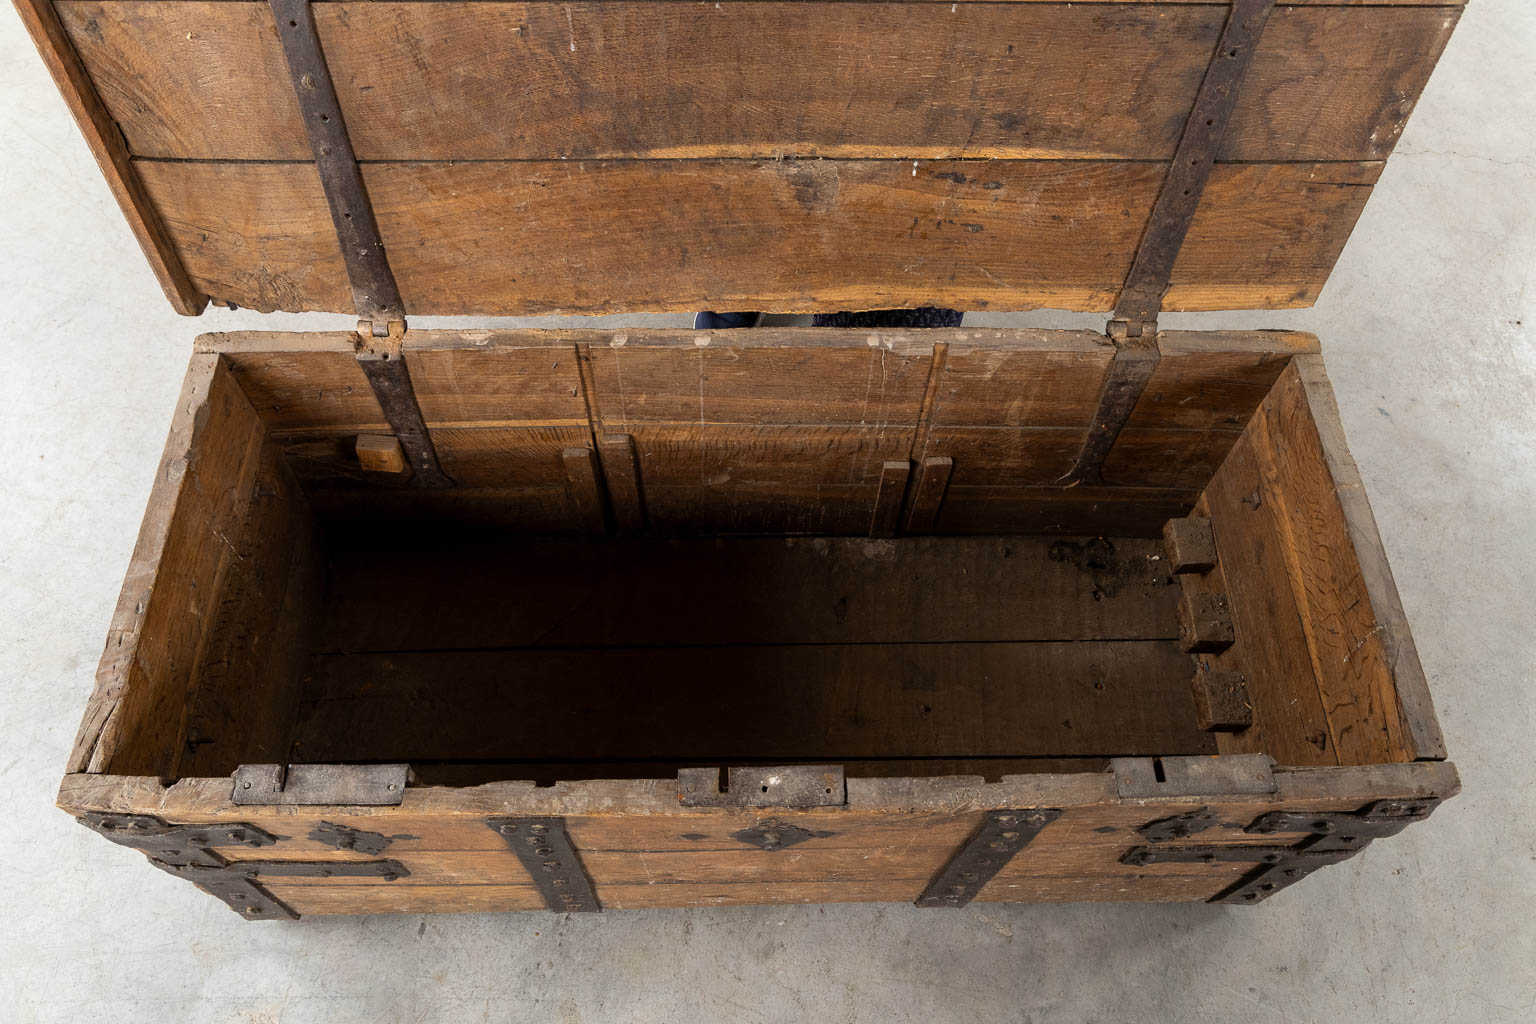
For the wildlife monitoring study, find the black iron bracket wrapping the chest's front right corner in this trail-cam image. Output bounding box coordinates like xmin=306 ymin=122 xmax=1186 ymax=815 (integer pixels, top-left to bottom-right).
xmin=1120 ymin=800 xmax=1438 ymax=903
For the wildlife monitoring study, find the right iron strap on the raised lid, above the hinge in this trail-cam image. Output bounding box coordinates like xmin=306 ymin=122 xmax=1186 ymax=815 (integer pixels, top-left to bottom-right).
xmin=1115 ymin=0 xmax=1275 ymax=327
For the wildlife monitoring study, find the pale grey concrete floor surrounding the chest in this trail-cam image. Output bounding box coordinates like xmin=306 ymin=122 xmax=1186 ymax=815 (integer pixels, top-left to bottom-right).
xmin=0 ymin=0 xmax=1536 ymax=1024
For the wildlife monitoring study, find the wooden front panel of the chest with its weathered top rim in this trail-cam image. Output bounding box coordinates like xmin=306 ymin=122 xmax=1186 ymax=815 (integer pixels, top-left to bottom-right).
xmin=60 ymin=763 xmax=1458 ymax=913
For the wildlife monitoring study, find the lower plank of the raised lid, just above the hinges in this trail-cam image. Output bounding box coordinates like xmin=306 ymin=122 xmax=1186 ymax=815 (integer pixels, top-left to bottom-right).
xmin=137 ymin=160 xmax=1379 ymax=315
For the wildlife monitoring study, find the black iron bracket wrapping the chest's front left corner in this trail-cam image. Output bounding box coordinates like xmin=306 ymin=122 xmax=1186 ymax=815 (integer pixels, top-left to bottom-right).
xmin=78 ymin=811 xmax=410 ymax=921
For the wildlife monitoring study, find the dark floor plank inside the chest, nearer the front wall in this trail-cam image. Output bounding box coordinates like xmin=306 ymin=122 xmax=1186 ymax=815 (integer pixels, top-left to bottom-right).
xmin=293 ymin=640 xmax=1209 ymax=763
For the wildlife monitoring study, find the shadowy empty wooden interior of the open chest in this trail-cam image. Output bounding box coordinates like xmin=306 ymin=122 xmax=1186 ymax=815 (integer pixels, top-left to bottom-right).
xmin=77 ymin=329 xmax=1422 ymax=785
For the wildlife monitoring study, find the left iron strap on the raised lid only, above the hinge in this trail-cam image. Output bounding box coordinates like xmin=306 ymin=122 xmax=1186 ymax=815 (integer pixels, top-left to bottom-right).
xmin=269 ymin=0 xmax=406 ymax=322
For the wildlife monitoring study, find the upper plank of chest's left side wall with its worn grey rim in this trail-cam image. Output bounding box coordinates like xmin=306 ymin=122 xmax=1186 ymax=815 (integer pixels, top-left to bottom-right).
xmin=72 ymin=355 xmax=264 ymax=774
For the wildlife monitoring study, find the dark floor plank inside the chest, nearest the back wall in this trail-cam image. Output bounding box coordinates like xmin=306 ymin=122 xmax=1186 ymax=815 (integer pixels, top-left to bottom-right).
xmin=316 ymin=537 xmax=1178 ymax=652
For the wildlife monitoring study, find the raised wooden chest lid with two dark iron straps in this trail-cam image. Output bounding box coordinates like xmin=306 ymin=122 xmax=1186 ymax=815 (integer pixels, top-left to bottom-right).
xmin=17 ymin=0 xmax=1461 ymax=323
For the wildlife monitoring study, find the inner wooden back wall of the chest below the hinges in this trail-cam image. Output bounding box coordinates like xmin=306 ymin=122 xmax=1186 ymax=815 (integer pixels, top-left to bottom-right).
xmin=203 ymin=329 xmax=1316 ymax=536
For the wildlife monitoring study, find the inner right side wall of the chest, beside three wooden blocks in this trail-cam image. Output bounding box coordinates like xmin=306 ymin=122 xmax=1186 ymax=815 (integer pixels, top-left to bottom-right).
xmin=1186 ymin=356 xmax=1425 ymax=765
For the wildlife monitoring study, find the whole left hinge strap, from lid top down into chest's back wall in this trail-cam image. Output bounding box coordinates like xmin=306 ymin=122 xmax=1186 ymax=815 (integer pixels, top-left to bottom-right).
xmin=269 ymin=0 xmax=453 ymax=487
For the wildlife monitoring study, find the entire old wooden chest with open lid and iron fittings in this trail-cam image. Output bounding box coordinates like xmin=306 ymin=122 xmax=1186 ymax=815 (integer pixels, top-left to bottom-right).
xmin=17 ymin=0 xmax=1459 ymax=920
